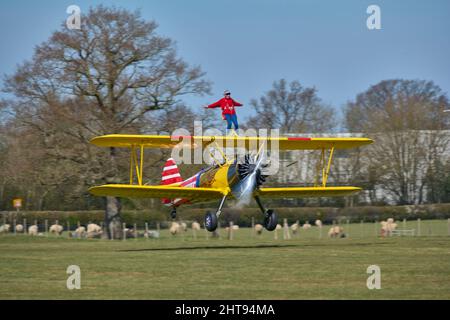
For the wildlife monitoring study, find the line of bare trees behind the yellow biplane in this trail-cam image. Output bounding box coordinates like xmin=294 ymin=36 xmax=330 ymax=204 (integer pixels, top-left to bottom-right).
xmin=0 ymin=6 xmax=450 ymax=235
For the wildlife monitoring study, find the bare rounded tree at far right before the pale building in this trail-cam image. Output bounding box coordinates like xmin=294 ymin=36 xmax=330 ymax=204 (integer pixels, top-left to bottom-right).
xmin=345 ymin=80 xmax=449 ymax=204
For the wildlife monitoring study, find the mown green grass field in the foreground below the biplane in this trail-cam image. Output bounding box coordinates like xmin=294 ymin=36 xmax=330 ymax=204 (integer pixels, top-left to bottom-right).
xmin=0 ymin=220 xmax=450 ymax=299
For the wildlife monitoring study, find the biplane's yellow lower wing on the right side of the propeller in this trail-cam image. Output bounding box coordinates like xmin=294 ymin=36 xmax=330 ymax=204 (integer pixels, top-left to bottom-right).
xmin=256 ymin=187 xmax=361 ymax=198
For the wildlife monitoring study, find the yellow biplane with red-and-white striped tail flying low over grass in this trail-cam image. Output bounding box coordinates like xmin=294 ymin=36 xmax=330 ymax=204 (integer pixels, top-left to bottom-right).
xmin=89 ymin=134 xmax=373 ymax=231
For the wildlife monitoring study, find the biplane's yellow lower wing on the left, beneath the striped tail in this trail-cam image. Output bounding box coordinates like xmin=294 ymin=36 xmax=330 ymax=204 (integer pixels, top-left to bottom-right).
xmin=89 ymin=184 xmax=226 ymax=202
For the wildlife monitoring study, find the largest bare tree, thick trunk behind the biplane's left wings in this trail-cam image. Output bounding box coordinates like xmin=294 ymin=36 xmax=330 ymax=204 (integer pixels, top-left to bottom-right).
xmin=4 ymin=6 xmax=209 ymax=238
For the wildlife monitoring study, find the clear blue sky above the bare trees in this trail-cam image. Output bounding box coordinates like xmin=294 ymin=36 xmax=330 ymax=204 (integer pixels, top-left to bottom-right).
xmin=0 ymin=0 xmax=450 ymax=124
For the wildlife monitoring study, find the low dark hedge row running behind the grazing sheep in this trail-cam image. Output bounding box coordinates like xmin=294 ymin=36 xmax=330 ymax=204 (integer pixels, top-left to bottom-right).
xmin=0 ymin=203 xmax=450 ymax=228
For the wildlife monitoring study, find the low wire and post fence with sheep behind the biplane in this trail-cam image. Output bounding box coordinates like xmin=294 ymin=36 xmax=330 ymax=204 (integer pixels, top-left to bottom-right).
xmin=0 ymin=216 xmax=450 ymax=240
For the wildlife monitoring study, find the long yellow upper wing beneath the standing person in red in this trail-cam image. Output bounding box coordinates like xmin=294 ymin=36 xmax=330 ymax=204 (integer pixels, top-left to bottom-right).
xmin=91 ymin=134 xmax=373 ymax=150
